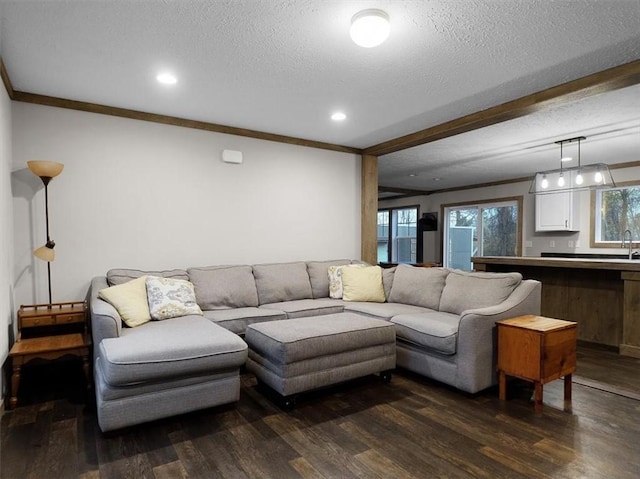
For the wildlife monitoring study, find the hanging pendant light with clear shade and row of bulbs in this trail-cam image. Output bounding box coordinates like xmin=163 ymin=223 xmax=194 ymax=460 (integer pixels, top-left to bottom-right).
xmin=529 ymin=136 xmax=616 ymax=195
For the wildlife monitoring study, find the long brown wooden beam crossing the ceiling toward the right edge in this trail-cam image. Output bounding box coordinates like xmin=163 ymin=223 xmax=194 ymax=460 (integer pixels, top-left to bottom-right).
xmin=364 ymin=60 xmax=640 ymax=156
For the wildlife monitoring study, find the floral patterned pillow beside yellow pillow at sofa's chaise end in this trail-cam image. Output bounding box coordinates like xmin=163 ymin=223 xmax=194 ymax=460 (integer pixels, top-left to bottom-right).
xmin=147 ymin=276 xmax=202 ymax=320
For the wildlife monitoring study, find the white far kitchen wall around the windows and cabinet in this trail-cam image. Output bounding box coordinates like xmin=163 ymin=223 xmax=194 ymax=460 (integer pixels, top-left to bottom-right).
xmin=378 ymin=166 xmax=640 ymax=262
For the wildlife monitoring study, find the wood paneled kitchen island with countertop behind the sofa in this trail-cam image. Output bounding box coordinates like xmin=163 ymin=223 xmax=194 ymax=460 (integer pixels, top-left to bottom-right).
xmin=471 ymin=256 xmax=640 ymax=358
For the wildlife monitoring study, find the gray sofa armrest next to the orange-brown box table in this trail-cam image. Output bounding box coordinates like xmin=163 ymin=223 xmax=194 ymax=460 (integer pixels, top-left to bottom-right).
xmin=456 ymin=280 xmax=542 ymax=393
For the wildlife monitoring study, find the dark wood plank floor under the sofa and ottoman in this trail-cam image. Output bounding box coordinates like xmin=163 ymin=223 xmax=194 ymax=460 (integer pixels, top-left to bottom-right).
xmin=0 ymin=348 xmax=640 ymax=479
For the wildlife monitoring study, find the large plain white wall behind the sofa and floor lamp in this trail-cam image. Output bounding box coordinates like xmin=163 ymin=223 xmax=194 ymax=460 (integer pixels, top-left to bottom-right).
xmin=13 ymin=102 xmax=360 ymax=304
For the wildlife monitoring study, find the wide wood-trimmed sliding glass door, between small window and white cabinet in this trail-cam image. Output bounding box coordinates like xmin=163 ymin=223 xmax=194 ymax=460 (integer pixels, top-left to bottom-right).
xmin=443 ymin=197 xmax=522 ymax=270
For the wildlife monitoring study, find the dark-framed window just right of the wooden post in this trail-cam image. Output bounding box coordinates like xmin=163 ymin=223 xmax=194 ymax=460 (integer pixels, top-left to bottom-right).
xmin=378 ymin=206 xmax=418 ymax=263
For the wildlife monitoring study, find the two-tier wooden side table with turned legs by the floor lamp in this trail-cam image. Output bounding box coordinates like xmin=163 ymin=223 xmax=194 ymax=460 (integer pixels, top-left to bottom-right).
xmin=9 ymin=301 xmax=91 ymax=409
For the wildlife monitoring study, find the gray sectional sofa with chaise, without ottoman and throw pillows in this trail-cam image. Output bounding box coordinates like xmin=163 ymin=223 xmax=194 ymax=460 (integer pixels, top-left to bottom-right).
xmin=88 ymin=259 xmax=541 ymax=431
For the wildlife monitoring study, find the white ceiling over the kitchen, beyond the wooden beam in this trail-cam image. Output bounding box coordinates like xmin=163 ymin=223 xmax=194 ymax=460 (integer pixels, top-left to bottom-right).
xmin=379 ymin=85 xmax=640 ymax=196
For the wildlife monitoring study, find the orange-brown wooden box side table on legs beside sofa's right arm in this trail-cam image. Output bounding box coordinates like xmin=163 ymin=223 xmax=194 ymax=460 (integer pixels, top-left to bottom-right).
xmin=496 ymin=315 xmax=577 ymax=412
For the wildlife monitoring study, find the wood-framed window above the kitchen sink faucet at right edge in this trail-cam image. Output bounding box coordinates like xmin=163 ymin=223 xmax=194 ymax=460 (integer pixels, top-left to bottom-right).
xmin=591 ymin=183 xmax=640 ymax=248
